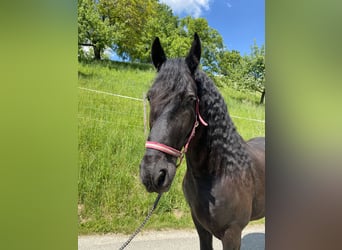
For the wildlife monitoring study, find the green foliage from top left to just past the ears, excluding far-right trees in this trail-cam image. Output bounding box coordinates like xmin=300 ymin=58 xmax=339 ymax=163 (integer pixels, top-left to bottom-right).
xmin=78 ymin=0 xmax=224 ymax=73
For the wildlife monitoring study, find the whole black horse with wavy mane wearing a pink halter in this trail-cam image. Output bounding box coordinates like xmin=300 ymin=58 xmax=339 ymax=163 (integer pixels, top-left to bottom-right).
xmin=140 ymin=34 xmax=265 ymax=250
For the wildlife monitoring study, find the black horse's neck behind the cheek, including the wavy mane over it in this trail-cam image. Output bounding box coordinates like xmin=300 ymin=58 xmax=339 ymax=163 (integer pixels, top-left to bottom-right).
xmin=187 ymin=71 xmax=250 ymax=174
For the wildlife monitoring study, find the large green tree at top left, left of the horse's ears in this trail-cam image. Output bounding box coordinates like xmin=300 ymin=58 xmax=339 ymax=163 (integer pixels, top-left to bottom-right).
xmin=78 ymin=0 xmax=157 ymax=60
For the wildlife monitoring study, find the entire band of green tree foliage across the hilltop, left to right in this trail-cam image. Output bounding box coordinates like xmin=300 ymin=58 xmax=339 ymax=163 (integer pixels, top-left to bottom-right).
xmin=78 ymin=0 xmax=265 ymax=98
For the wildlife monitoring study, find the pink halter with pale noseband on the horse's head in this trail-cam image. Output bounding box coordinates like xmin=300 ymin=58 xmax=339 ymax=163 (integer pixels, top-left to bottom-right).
xmin=145 ymin=97 xmax=208 ymax=167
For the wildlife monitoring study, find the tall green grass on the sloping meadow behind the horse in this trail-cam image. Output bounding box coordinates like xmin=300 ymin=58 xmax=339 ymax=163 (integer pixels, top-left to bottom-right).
xmin=78 ymin=61 xmax=265 ymax=234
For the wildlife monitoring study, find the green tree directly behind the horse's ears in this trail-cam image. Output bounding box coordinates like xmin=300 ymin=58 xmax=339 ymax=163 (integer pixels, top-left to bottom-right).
xmin=140 ymin=11 xmax=224 ymax=74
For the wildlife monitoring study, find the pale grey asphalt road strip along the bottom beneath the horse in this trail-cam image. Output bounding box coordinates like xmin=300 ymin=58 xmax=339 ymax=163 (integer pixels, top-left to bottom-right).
xmin=78 ymin=225 xmax=265 ymax=250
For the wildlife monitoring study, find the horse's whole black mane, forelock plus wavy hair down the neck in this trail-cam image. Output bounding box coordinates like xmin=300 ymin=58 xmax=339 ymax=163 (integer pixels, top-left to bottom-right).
xmin=147 ymin=58 xmax=251 ymax=174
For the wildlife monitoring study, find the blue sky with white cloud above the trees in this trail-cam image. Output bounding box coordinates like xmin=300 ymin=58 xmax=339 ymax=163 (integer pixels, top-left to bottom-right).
xmin=160 ymin=0 xmax=265 ymax=55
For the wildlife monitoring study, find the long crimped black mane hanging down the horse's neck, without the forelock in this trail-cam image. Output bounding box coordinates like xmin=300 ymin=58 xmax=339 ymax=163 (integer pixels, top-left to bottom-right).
xmin=195 ymin=70 xmax=251 ymax=174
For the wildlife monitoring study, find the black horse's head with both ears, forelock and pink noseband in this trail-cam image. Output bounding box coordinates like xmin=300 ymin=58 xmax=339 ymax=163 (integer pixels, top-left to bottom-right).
xmin=140 ymin=34 xmax=201 ymax=193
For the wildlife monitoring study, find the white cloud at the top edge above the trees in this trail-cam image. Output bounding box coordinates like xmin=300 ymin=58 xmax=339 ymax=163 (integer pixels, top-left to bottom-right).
xmin=160 ymin=0 xmax=210 ymax=17
